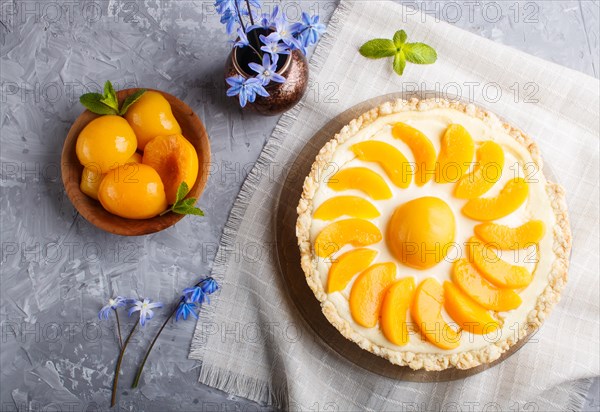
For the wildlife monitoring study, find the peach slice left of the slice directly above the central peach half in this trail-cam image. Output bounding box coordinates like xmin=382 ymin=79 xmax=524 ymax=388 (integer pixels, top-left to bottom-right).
xmin=350 ymin=140 xmax=412 ymax=189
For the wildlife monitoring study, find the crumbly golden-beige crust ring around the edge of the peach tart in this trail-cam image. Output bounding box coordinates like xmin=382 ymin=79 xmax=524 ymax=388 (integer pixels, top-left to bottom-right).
xmin=296 ymin=98 xmax=571 ymax=371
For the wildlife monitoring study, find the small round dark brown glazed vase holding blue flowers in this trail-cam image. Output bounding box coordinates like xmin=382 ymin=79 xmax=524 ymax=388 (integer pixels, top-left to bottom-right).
xmin=225 ymin=43 xmax=308 ymax=116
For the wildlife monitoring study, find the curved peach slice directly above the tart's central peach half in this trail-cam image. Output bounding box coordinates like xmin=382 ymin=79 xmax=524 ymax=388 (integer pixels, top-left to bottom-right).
xmin=392 ymin=122 xmax=435 ymax=186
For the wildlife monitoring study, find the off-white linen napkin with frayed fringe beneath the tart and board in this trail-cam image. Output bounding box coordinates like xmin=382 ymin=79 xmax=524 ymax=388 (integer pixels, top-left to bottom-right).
xmin=190 ymin=1 xmax=600 ymax=411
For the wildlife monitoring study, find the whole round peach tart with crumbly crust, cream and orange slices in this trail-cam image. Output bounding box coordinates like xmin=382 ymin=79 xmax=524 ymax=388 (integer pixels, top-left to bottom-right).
xmin=296 ymin=99 xmax=571 ymax=370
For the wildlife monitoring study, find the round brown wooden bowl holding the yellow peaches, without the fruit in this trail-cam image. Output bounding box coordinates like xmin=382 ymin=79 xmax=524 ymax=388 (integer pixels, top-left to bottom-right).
xmin=61 ymin=89 xmax=210 ymax=236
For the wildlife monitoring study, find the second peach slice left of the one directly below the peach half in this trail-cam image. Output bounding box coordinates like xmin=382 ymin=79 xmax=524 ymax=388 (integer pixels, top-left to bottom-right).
xmin=348 ymin=262 xmax=396 ymax=328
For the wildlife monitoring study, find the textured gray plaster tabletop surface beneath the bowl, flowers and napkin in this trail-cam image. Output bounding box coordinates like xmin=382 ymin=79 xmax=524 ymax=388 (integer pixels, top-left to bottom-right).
xmin=0 ymin=0 xmax=599 ymax=411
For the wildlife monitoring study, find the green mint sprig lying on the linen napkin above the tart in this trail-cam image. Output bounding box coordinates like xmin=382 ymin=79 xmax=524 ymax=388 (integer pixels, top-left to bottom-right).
xmin=359 ymin=30 xmax=437 ymax=76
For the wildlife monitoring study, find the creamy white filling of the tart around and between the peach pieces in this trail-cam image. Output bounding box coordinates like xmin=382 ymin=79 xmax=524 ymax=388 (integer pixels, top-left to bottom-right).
xmin=310 ymin=108 xmax=555 ymax=353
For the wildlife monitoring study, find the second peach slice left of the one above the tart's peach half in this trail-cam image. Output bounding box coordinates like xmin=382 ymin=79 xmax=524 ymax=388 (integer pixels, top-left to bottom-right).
xmin=327 ymin=167 xmax=392 ymax=200
